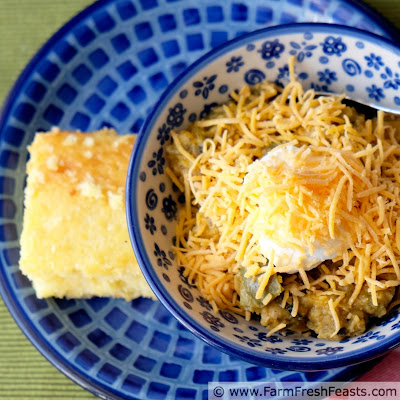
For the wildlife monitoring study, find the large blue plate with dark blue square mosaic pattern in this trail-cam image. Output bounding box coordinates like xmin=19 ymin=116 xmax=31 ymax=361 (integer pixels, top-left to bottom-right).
xmin=0 ymin=0 xmax=399 ymax=399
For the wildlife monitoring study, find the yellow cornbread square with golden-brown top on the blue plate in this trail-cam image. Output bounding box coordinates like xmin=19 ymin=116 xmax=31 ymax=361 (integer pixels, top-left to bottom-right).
xmin=20 ymin=129 xmax=155 ymax=300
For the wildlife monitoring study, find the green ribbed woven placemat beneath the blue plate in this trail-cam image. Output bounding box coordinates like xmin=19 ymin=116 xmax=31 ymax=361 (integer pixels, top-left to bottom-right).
xmin=0 ymin=0 xmax=400 ymax=400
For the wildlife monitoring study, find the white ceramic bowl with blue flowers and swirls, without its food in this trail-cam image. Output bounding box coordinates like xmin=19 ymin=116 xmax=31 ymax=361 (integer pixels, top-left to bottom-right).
xmin=126 ymin=24 xmax=400 ymax=370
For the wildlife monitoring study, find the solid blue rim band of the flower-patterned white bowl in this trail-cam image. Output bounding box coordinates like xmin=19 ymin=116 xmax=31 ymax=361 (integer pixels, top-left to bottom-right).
xmin=125 ymin=23 xmax=400 ymax=371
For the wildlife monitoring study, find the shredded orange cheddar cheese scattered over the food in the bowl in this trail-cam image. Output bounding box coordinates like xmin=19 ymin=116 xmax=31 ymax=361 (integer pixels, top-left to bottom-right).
xmin=168 ymin=60 xmax=400 ymax=334
